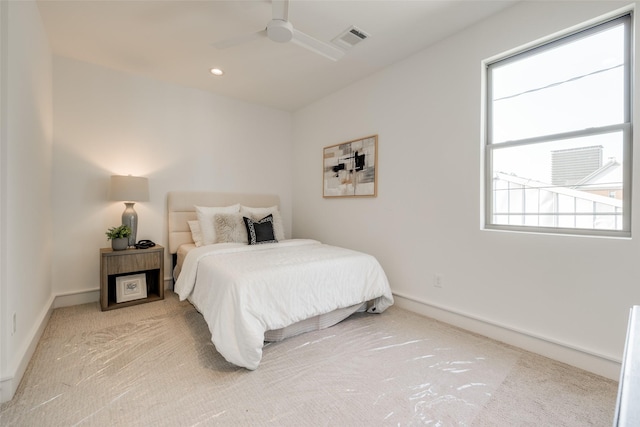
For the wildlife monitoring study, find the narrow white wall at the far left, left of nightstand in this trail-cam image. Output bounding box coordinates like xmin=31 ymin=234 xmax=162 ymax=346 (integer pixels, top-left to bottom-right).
xmin=0 ymin=1 xmax=52 ymax=401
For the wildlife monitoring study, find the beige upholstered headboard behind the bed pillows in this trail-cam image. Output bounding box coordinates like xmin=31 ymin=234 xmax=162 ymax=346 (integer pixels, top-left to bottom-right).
xmin=167 ymin=191 xmax=280 ymax=254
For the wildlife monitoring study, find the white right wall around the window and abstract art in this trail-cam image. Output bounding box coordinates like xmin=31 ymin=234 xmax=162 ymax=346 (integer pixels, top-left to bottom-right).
xmin=293 ymin=2 xmax=640 ymax=379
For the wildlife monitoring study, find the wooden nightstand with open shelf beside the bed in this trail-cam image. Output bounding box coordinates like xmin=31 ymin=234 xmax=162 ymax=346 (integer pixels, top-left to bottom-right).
xmin=100 ymin=245 xmax=164 ymax=311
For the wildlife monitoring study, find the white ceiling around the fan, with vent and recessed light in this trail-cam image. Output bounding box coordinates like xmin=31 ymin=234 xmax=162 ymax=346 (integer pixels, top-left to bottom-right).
xmin=38 ymin=0 xmax=514 ymax=111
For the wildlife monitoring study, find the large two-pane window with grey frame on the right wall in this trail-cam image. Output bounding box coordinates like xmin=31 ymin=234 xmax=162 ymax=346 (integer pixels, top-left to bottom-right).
xmin=485 ymin=14 xmax=632 ymax=236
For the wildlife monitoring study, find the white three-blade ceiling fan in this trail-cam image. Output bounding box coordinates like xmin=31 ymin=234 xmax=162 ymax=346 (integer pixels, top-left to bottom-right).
xmin=213 ymin=0 xmax=344 ymax=61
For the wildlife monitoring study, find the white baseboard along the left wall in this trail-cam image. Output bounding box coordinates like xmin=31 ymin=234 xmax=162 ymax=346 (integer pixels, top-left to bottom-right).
xmin=0 ymin=295 xmax=55 ymax=403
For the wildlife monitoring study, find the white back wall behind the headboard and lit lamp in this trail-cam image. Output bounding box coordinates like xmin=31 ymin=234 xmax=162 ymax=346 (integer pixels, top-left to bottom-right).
xmin=53 ymin=57 xmax=292 ymax=303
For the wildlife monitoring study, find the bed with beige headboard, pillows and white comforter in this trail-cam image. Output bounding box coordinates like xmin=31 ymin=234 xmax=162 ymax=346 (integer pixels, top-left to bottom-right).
xmin=167 ymin=192 xmax=393 ymax=370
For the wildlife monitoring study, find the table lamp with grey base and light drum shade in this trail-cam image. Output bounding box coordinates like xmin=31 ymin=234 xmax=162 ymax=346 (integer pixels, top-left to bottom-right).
xmin=109 ymin=175 xmax=149 ymax=247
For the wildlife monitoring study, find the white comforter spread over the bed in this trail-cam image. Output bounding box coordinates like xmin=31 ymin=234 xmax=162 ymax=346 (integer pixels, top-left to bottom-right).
xmin=175 ymin=239 xmax=393 ymax=369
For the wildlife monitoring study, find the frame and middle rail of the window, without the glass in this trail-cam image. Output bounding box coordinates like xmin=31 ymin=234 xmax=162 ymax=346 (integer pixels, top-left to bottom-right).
xmin=483 ymin=11 xmax=633 ymax=237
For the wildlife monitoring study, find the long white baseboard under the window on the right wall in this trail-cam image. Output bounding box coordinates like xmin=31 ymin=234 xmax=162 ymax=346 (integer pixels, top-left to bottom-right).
xmin=393 ymin=292 xmax=622 ymax=381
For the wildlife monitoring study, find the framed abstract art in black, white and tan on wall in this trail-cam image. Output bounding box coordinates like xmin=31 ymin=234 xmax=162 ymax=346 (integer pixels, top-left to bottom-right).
xmin=322 ymin=135 xmax=378 ymax=198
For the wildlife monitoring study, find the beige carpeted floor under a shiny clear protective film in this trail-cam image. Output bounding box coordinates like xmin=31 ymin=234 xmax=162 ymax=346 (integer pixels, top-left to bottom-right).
xmin=0 ymin=292 xmax=617 ymax=426
